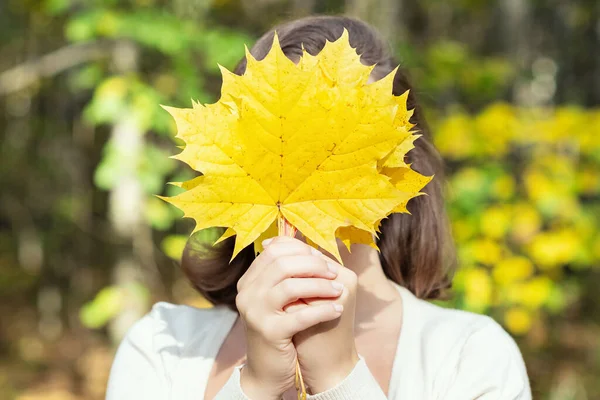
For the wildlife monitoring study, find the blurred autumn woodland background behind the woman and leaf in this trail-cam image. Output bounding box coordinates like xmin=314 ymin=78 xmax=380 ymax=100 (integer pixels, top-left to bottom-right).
xmin=0 ymin=0 xmax=600 ymax=400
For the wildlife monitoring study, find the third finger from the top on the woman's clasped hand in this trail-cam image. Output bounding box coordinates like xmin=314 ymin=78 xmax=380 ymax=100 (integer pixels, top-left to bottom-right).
xmin=267 ymin=278 xmax=344 ymax=310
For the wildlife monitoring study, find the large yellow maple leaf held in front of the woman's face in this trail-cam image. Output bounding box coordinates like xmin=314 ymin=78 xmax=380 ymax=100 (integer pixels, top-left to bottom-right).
xmin=163 ymin=31 xmax=430 ymax=261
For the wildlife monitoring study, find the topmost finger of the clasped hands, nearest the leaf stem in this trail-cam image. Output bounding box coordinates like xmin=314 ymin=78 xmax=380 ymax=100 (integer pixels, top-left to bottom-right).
xmin=237 ymin=236 xmax=316 ymax=292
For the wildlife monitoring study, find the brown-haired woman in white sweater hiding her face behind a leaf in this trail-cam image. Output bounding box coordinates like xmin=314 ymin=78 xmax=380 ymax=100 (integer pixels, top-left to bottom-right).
xmin=107 ymin=17 xmax=531 ymax=400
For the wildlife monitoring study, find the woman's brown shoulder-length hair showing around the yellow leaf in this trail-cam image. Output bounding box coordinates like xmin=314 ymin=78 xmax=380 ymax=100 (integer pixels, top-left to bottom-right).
xmin=182 ymin=16 xmax=455 ymax=309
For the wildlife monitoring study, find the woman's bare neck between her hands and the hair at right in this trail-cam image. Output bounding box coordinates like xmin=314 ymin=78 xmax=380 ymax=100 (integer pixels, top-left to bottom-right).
xmin=340 ymin=244 xmax=400 ymax=324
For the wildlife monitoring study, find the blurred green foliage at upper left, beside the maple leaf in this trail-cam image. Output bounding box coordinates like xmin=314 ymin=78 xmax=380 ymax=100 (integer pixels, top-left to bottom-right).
xmin=65 ymin=2 xmax=251 ymax=244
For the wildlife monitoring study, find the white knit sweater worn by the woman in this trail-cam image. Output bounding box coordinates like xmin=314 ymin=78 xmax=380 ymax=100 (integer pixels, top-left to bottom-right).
xmin=107 ymin=285 xmax=531 ymax=400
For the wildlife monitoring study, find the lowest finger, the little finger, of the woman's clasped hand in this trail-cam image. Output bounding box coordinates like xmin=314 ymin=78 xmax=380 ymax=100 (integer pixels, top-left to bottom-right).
xmin=279 ymin=303 xmax=344 ymax=337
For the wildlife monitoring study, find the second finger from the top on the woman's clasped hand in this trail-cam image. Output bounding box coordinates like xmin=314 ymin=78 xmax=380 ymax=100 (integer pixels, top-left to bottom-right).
xmin=260 ymin=255 xmax=339 ymax=286
